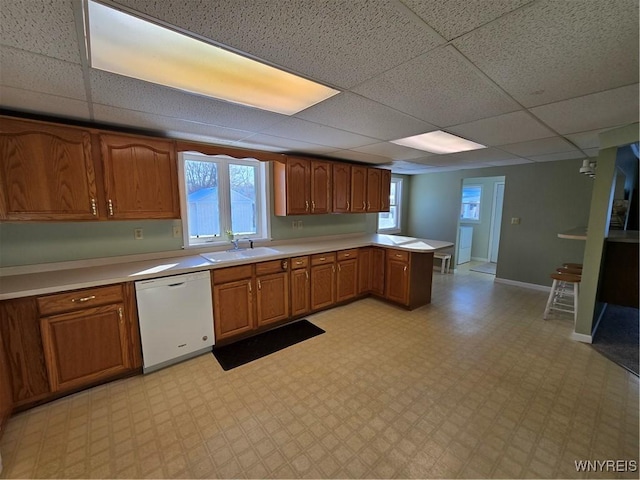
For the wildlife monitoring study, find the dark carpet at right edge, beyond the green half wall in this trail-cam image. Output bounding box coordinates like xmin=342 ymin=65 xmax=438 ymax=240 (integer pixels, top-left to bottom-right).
xmin=591 ymin=304 xmax=640 ymax=375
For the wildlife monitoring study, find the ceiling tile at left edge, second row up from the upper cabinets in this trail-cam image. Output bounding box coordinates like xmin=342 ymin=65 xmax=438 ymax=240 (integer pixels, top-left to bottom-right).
xmin=0 ymin=47 xmax=87 ymax=100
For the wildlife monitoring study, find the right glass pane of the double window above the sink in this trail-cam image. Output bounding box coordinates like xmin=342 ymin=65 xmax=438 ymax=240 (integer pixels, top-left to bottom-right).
xmin=229 ymin=164 xmax=258 ymax=235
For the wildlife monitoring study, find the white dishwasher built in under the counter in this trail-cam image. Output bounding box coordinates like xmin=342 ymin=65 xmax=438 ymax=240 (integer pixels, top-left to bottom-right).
xmin=135 ymin=271 xmax=215 ymax=373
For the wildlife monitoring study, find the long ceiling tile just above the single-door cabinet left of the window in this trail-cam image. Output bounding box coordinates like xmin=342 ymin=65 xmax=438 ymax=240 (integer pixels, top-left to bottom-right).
xmin=93 ymin=104 xmax=252 ymax=144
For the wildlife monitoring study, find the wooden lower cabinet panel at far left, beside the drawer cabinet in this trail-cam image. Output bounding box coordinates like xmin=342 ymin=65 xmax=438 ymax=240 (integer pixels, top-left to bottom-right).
xmin=0 ymin=298 xmax=50 ymax=406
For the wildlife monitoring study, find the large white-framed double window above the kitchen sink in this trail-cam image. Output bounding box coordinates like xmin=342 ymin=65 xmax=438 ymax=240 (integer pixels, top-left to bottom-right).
xmin=180 ymin=153 xmax=269 ymax=247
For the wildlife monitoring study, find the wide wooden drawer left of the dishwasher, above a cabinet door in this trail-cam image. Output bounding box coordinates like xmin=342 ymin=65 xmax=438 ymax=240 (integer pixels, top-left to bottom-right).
xmin=38 ymin=285 xmax=123 ymax=316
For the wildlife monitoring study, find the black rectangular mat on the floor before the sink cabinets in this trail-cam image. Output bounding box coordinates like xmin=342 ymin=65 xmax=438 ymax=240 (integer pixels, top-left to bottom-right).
xmin=213 ymin=320 xmax=324 ymax=370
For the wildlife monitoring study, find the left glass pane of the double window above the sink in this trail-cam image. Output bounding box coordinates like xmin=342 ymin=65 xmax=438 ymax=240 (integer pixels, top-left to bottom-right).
xmin=184 ymin=160 xmax=220 ymax=238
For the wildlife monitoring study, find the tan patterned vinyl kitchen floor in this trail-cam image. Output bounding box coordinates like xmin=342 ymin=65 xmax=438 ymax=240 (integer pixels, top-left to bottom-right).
xmin=0 ymin=268 xmax=639 ymax=478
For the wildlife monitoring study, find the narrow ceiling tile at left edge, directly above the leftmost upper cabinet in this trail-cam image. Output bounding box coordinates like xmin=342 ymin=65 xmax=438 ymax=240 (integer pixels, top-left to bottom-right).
xmin=0 ymin=87 xmax=91 ymax=120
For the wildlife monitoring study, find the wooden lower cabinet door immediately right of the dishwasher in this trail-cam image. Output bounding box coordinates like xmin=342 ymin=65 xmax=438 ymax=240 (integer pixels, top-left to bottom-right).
xmin=213 ymin=279 xmax=255 ymax=340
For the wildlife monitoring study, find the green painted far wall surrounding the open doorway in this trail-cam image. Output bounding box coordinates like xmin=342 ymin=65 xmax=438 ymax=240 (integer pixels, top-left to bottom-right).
xmin=407 ymin=160 xmax=593 ymax=286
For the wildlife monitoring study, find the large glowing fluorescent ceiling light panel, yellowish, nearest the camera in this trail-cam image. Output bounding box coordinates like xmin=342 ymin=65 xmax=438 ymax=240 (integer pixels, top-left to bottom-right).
xmin=88 ymin=1 xmax=339 ymax=115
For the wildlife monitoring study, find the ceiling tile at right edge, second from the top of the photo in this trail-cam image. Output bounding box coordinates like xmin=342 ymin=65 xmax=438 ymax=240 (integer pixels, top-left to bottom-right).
xmin=530 ymin=83 xmax=639 ymax=134
